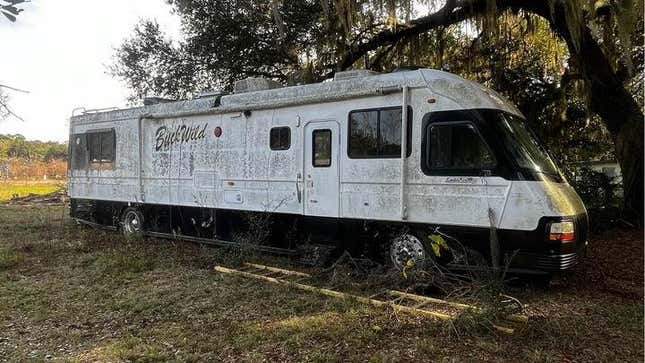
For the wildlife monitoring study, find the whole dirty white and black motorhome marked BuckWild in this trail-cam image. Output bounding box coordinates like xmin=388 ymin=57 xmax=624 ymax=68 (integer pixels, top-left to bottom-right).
xmin=68 ymin=69 xmax=588 ymax=272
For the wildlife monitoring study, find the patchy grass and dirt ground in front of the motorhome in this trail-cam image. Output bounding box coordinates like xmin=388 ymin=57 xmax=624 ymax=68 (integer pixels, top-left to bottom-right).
xmin=0 ymin=205 xmax=644 ymax=362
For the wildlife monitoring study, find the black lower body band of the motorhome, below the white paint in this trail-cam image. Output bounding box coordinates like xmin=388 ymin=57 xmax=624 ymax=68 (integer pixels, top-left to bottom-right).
xmin=70 ymin=199 xmax=588 ymax=272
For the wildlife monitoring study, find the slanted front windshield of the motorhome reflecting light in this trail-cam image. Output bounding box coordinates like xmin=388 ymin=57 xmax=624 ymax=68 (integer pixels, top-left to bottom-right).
xmin=490 ymin=112 xmax=562 ymax=181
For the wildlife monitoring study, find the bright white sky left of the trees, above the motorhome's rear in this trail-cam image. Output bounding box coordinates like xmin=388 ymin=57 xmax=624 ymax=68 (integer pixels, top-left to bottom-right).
xmin=0 ymin=0 xmax=181 ymax=141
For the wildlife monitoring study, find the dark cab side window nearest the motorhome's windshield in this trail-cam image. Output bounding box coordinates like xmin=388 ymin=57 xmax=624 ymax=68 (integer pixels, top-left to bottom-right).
xmin=425 ymin=122 xmax=495 ymax=175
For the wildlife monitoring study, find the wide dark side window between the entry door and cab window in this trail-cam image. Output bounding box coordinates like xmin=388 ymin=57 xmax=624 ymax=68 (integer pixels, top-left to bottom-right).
xmin=347 ymin=107 xmax=412 ymax=159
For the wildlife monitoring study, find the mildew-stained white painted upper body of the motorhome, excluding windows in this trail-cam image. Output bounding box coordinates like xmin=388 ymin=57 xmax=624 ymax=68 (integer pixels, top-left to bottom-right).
xmin=69 ymin=70 xmax=584 ymax=230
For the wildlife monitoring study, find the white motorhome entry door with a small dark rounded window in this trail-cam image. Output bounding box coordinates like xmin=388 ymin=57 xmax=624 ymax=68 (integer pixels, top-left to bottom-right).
xmin=304 ymin=121 xmax=340 ymax=217
